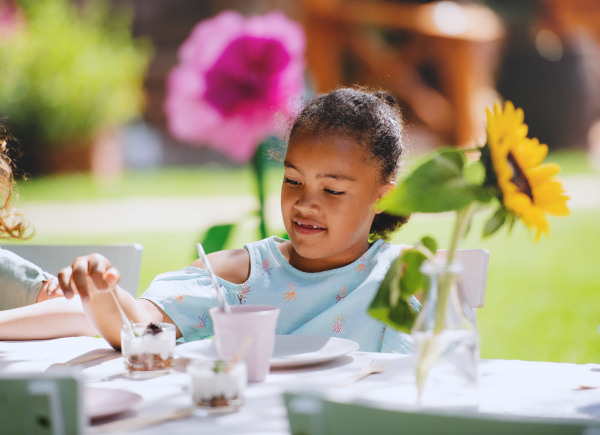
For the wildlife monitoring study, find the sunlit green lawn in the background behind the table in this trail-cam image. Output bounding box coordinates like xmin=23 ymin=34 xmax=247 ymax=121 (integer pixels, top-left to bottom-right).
xmin=9 ymin=152 xmax=600 ymax=363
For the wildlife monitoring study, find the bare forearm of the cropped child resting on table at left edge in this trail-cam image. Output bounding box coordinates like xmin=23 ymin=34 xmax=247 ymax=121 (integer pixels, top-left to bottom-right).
xmin=0 ymin=297 xmax=98 ymax=340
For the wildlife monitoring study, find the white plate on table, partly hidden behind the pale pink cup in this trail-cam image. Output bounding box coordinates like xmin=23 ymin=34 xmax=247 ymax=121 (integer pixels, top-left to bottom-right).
xmin=175 ymin=335 xmax=359 ymax=368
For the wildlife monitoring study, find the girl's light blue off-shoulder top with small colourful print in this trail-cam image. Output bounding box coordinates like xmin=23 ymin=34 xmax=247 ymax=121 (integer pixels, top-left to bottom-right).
xmin=141 ymin=237 xmax=418 ymax=353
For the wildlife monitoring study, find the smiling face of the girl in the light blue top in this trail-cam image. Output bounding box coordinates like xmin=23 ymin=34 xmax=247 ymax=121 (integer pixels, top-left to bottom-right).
xmin=281 ymin=136 xmax=393 ymax=272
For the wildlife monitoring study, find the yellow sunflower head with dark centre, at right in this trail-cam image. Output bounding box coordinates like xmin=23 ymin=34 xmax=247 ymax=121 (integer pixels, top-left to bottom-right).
xmin=486 ymin=101 xmax=569 ymax=240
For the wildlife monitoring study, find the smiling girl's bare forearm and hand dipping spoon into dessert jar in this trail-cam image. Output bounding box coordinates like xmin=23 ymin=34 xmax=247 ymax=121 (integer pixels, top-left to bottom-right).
xmin=58 ymin=254 xmax=181 ymax=349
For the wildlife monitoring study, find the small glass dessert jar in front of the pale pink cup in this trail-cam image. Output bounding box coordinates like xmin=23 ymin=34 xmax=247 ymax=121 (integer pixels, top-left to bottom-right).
xmin=187 ymin=359 xmax=248 ymax=416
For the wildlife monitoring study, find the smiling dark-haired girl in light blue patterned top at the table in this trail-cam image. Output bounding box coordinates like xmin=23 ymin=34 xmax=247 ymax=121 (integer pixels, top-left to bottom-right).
xmin=59 ymin=89 xmax=410 ymax=353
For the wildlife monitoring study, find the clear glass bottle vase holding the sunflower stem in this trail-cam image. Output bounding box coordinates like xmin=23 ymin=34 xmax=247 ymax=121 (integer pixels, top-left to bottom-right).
xmin=412 ymin=260 xmax=479 ymax=410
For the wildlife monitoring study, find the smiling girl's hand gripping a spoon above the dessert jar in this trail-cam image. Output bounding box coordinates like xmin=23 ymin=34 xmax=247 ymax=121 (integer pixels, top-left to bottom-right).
xmin=58 ymin=254 xmax=121 ymax=302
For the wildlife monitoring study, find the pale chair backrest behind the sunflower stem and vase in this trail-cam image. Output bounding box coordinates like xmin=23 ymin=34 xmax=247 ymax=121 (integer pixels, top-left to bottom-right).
xmin=436 ymin=249 xmax=490 ymax=308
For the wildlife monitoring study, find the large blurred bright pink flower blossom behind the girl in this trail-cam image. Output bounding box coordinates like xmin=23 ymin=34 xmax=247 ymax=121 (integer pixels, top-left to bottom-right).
xmin=164 ymin=11 xmax=305 ymax=163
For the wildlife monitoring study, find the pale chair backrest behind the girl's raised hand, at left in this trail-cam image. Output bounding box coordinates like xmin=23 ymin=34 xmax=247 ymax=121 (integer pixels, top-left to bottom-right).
xmin=1 ymin=243 xmax=143 ymax=297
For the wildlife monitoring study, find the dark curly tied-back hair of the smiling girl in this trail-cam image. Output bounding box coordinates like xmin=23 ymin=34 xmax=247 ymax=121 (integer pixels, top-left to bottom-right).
xmin=288 ymin=87 xmax=408 ymax=241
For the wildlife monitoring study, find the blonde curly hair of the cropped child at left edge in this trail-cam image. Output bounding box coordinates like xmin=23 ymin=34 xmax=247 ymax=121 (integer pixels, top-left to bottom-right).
xmin=0 ymin=124 xmax=32 ymax=239
